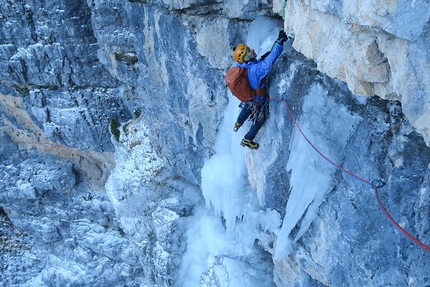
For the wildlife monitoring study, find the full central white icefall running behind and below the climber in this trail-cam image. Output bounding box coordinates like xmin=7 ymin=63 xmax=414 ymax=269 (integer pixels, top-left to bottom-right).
xmin=175 ymin=18 xmax=281 ymax=287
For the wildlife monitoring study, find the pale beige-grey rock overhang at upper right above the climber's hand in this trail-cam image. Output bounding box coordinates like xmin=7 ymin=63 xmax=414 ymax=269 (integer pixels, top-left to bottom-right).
xmin=285 ymin=0 xmax=430 ymax=145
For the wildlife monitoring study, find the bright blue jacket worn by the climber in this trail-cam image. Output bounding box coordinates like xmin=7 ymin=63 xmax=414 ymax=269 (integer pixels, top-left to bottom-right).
xmin=237 ymin=43 xmax=284 ymax=90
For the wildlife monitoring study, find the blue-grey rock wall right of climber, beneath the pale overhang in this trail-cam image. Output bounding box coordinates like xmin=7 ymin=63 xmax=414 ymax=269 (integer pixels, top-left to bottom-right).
xmin=254 ymin=52 xmax=430 ymax=286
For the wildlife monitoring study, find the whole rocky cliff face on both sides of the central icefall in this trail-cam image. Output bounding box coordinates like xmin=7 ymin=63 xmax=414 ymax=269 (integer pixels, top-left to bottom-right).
xmin=0 ymin=0 xmax=430 ymax=286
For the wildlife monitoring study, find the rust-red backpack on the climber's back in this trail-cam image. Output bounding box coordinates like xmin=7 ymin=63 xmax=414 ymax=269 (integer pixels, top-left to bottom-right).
xmin=225 ymin=66 xmax=266 ymax=103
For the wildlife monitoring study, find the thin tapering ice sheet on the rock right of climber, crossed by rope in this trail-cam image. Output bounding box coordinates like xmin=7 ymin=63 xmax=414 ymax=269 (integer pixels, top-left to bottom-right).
xmin=274 ymin=83 xmax=360 ymax=260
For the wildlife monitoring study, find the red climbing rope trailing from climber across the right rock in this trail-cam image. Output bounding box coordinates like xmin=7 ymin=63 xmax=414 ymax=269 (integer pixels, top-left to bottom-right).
xmin=270 ymin=95 xmax=430 ymax=252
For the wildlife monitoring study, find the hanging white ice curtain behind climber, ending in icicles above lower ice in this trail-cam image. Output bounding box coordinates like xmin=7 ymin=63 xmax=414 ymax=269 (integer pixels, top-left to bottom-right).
xmin=202 ymin=17 xmax=281 ymax=233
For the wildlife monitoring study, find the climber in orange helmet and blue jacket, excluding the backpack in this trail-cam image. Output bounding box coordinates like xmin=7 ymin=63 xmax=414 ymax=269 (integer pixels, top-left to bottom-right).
xmin=233 ymin=30 xmax=288 ymax=149
